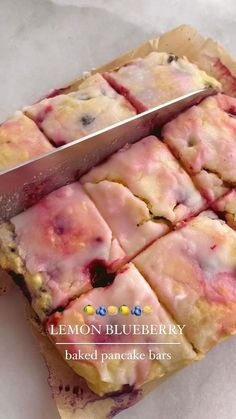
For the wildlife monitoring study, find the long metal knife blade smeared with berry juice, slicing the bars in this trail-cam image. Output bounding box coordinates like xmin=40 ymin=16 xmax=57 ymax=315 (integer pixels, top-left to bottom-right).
xmin=0 ymin=88 xmax=217 ymax=222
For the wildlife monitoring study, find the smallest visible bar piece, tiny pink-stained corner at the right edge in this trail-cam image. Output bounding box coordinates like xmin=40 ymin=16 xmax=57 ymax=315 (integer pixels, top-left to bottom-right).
xmin=212 ymin=189 xmax=236 ymax=230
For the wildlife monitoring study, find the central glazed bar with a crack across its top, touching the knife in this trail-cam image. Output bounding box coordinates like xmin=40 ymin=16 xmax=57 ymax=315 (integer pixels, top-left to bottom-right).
xmin=81 ymin=136 xmax=205 ymax=257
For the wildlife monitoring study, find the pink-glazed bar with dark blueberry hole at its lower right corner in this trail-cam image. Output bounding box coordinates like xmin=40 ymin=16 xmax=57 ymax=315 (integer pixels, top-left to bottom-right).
xmin=0 ymin=183 xmax=124 ymax=319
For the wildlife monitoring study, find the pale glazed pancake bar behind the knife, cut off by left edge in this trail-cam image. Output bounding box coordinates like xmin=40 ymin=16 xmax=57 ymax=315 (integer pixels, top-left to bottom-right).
xmin=0 ymin=111 xmax=53 ymax=171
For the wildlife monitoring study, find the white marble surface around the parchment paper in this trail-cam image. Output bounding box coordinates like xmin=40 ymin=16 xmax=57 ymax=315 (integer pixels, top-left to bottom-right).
xmin=0 ymin=0 xmax=236 ymax=419
